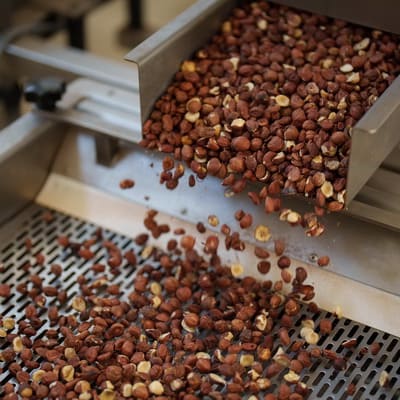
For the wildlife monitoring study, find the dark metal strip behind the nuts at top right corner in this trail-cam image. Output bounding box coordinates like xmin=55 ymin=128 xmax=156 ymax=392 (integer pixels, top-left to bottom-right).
xmin=273 ymin=0 xmax=400 ymax=34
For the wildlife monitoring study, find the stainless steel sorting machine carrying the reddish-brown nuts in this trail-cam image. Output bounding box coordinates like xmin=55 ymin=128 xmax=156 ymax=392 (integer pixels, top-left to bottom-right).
xmin=0 ymin=0 xmax=400 ymax=400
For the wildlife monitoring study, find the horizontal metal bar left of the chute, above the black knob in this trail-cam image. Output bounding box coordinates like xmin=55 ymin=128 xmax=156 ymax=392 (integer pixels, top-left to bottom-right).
xmin=4 ymin=38 xmax=139 ymax=92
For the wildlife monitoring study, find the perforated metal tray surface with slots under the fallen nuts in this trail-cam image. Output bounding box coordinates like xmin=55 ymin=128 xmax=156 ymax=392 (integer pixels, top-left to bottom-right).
xmin=0 ymin=205 xmax=400 ymax=400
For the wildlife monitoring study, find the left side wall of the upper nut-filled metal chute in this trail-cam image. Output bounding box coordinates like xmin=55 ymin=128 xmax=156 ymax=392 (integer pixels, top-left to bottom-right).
xmin=125 ymin=0 xmax=233 ymax=122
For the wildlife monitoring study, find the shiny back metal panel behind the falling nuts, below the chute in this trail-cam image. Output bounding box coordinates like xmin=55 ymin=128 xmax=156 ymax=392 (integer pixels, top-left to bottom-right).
xmin=49 ymin=134 xmax=400 ymax=296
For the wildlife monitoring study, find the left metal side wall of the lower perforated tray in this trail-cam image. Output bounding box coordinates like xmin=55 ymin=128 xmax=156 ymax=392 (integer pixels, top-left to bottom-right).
xmin=0 ymin=114 xmax=63 ymax=225
